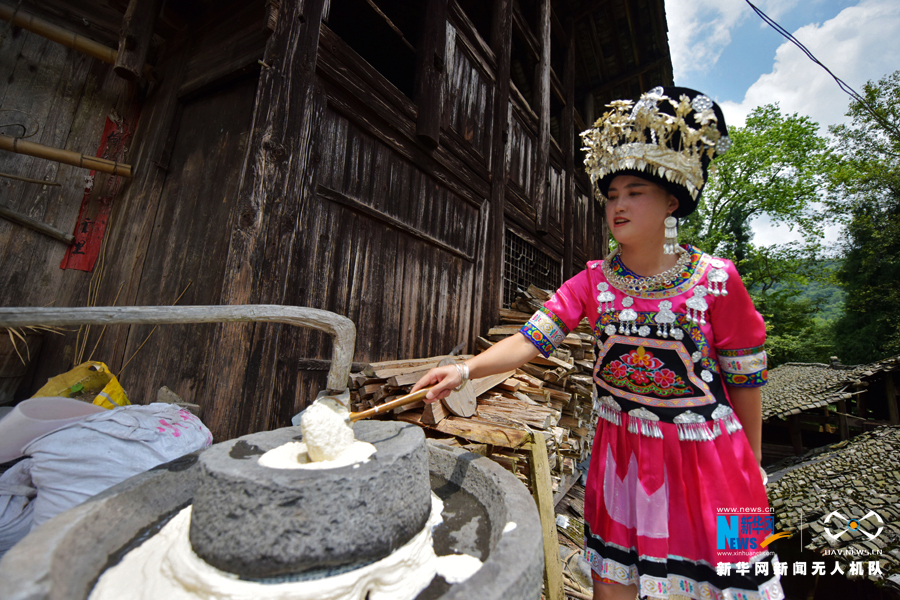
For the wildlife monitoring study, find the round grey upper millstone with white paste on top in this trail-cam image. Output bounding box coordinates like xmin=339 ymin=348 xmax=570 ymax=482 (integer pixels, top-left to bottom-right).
xmin=190 ymin=421 xmax=431 ymax=579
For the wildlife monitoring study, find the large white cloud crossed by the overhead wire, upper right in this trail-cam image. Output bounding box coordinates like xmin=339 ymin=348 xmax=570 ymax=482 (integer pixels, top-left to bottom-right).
xmin=720 ymin=0 xmax=900 ymax=129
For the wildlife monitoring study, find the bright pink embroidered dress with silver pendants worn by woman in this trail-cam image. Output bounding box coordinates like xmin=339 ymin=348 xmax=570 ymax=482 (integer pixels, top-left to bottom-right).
xmin=521 ymin=246 xmax=784 ymax=600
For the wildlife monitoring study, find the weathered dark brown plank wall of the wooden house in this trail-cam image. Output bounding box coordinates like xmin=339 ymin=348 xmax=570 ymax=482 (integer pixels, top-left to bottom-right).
xmin=0 ymin=0 xmax=599 ymax=439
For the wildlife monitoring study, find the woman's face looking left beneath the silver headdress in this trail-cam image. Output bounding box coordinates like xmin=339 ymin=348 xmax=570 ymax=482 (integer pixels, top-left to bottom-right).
xmin=606 ymin=175 xmax=678 ymax=245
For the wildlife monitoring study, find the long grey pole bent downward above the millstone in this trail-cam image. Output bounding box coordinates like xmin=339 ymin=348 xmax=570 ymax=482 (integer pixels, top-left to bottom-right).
xmin=0 ymin=304 xmax=356 ymax=392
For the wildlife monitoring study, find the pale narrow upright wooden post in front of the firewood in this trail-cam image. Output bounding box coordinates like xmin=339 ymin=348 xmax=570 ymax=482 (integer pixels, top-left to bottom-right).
xmin=527 ymin=431 xmax=566 ymax=600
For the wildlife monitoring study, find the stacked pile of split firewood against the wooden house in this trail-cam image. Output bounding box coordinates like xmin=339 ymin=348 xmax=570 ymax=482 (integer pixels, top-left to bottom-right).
xmin=350 ymin=286 xmax=597 ymax=493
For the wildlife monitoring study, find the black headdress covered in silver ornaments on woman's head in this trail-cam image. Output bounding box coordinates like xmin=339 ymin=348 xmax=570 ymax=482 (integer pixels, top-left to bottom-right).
xmin=581 ymin=87 xmax=731 ymax=216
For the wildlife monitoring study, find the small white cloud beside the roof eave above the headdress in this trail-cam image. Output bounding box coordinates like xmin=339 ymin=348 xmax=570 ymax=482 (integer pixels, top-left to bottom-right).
xmin=666 ymin=0 xmax=799 ymax=81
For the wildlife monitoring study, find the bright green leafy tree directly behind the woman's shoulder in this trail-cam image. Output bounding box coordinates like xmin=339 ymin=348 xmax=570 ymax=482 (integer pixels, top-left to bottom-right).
xmin=683 ymin=104 xmax=839 ymax=367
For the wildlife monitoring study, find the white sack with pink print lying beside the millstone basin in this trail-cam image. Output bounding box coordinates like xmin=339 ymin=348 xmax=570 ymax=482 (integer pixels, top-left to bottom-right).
xmin=23 ymin=403 xmax=212 ymax=527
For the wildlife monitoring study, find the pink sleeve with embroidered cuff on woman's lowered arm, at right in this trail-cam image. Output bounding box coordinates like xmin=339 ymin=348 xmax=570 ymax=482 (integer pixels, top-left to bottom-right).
xmin=707 ymin=259 xmax=768 ymax=387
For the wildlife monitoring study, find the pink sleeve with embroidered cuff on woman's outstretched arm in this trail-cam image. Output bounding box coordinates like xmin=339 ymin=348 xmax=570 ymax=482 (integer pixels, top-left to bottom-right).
xmin=519 ymin=271 xmax=591 ymax=356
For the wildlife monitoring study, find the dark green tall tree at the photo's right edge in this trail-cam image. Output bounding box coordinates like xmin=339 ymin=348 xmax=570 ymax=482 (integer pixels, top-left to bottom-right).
xmin=831 ymin=71 xmax=900 ymax=364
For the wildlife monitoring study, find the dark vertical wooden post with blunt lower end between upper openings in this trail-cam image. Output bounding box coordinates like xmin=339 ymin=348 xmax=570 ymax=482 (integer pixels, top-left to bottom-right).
xmin=415 ymin=0 xmax=447 ymax=150
